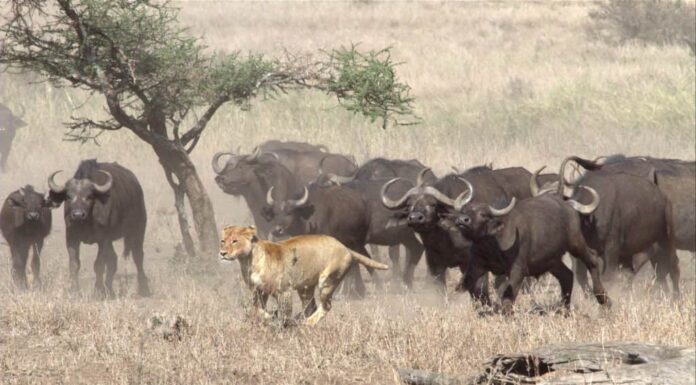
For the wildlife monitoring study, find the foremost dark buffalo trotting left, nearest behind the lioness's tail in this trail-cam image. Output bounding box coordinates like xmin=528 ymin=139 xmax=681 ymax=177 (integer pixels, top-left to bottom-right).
xmin=452 ymin=180 xmax=608 ymax=314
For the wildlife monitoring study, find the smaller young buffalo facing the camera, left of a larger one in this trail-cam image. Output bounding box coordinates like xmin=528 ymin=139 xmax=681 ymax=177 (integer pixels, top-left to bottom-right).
xmin=0 ymin=185 xmax=51 ymax=288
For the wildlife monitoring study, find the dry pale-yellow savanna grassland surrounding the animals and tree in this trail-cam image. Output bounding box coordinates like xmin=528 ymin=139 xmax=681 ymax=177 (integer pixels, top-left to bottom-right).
xmin=0 ymin=1 xmax=696 ymax=384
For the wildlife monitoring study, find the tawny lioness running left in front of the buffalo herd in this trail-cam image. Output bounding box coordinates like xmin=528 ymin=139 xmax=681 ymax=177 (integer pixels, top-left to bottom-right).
xmin=220 ymin=226 xmax=389 ymax=325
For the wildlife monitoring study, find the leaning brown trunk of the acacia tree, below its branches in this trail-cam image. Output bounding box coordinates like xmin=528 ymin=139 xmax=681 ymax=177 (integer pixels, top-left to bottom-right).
xmin=153 ymin=142 xmax=217 ymax=255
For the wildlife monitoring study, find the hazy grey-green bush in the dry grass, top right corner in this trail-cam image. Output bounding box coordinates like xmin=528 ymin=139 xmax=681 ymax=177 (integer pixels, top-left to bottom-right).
xmin=588 ymin=0 xmax=696 ymax=45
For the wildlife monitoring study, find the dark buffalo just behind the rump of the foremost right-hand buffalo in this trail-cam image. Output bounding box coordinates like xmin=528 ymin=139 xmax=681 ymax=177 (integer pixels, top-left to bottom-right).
xmin=558 ymin=156 xmax=680 ymax=296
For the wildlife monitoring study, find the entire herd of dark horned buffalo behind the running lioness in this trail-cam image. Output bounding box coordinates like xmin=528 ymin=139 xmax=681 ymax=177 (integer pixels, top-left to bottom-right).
xmin=0 ymin=138 xmax=696 ymax=314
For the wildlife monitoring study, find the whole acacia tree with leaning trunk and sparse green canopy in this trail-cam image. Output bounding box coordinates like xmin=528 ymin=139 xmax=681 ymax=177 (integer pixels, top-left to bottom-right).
xmin=0 ymin=0 xmax=415 ymax=255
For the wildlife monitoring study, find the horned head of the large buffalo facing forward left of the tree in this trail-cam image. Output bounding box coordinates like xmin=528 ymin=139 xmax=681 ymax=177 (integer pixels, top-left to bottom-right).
xmin=48 ymin=170 xmax=113 ymax=222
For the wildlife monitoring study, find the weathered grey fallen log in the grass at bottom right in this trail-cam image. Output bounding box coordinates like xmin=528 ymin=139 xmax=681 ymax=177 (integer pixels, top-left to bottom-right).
xmin=395 ymin=342 xmax=696 ymax=385
